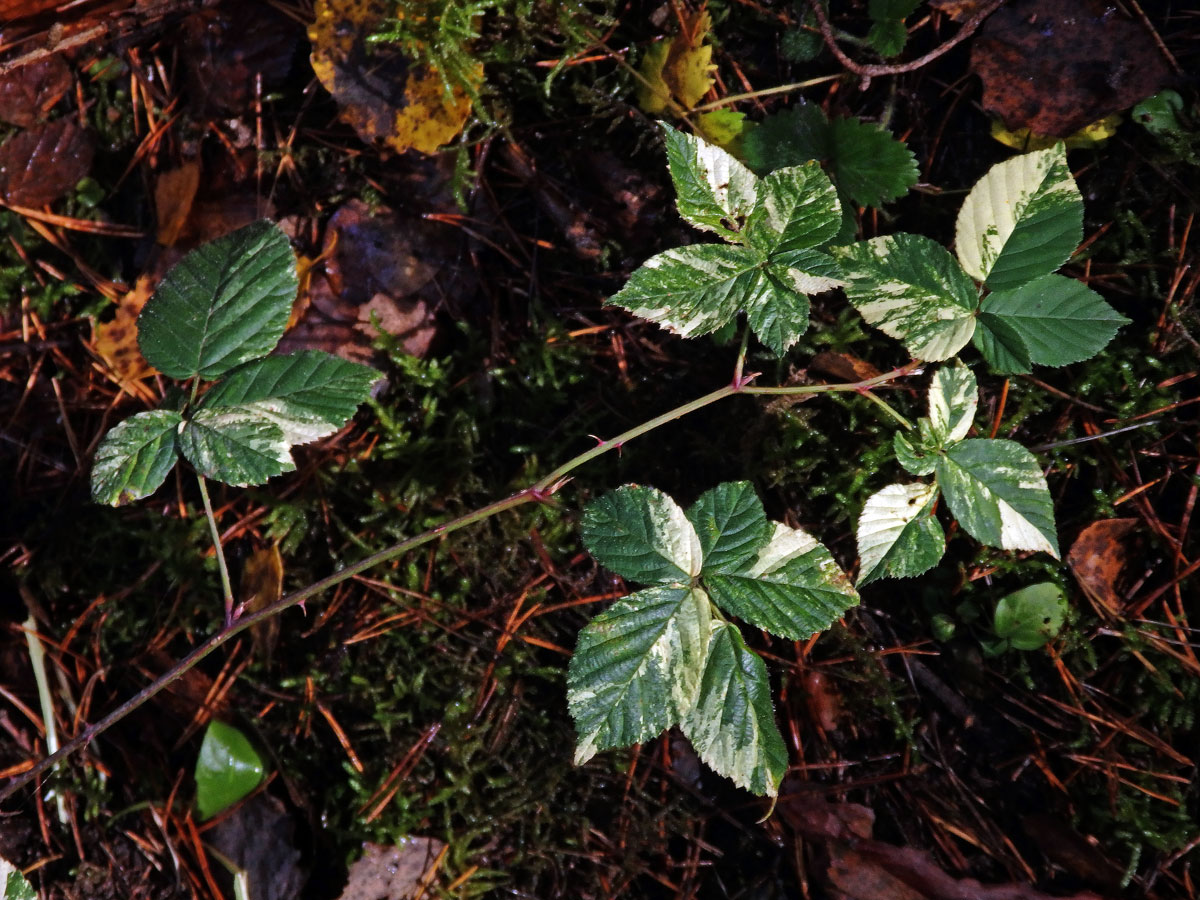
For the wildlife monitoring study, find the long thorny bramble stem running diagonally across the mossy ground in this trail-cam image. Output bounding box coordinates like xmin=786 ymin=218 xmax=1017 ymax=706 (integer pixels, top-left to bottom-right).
xmin=0 ymin=362 xmax=920 ymax=802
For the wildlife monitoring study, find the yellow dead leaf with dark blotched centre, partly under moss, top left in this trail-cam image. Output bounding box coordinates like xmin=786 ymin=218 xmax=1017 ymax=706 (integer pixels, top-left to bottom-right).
xmin=308 ymin=0 xmax=484 ymax=154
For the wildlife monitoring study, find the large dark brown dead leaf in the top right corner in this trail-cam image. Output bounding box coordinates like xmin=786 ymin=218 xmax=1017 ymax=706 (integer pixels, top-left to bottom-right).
xmin=971 ymin=0 xmax=1170 ymax=137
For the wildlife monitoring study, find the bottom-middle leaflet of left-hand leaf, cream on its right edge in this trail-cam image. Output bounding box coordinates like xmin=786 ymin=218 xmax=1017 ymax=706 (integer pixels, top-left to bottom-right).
xmin=179 ymin=407 xmax=295 ymax=487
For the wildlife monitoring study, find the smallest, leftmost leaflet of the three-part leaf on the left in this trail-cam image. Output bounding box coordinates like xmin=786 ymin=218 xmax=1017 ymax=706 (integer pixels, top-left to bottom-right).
xmin=91 ymin=409 xmax=184 ymax=506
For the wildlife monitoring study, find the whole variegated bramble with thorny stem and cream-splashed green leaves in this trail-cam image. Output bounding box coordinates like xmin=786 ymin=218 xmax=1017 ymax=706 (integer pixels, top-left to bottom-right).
xmin=7 ymin=125 xmax=1124 ymax=811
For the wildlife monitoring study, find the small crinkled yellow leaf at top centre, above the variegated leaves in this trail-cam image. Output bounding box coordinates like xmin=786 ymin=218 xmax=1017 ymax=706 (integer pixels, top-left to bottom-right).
xmin=637 ymin=10 xmax=716 ymax=114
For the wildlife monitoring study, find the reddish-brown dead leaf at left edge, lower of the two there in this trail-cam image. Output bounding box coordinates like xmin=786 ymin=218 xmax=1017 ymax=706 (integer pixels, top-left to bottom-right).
xmin=0 ymin=119 xmax=94 ymax=209
